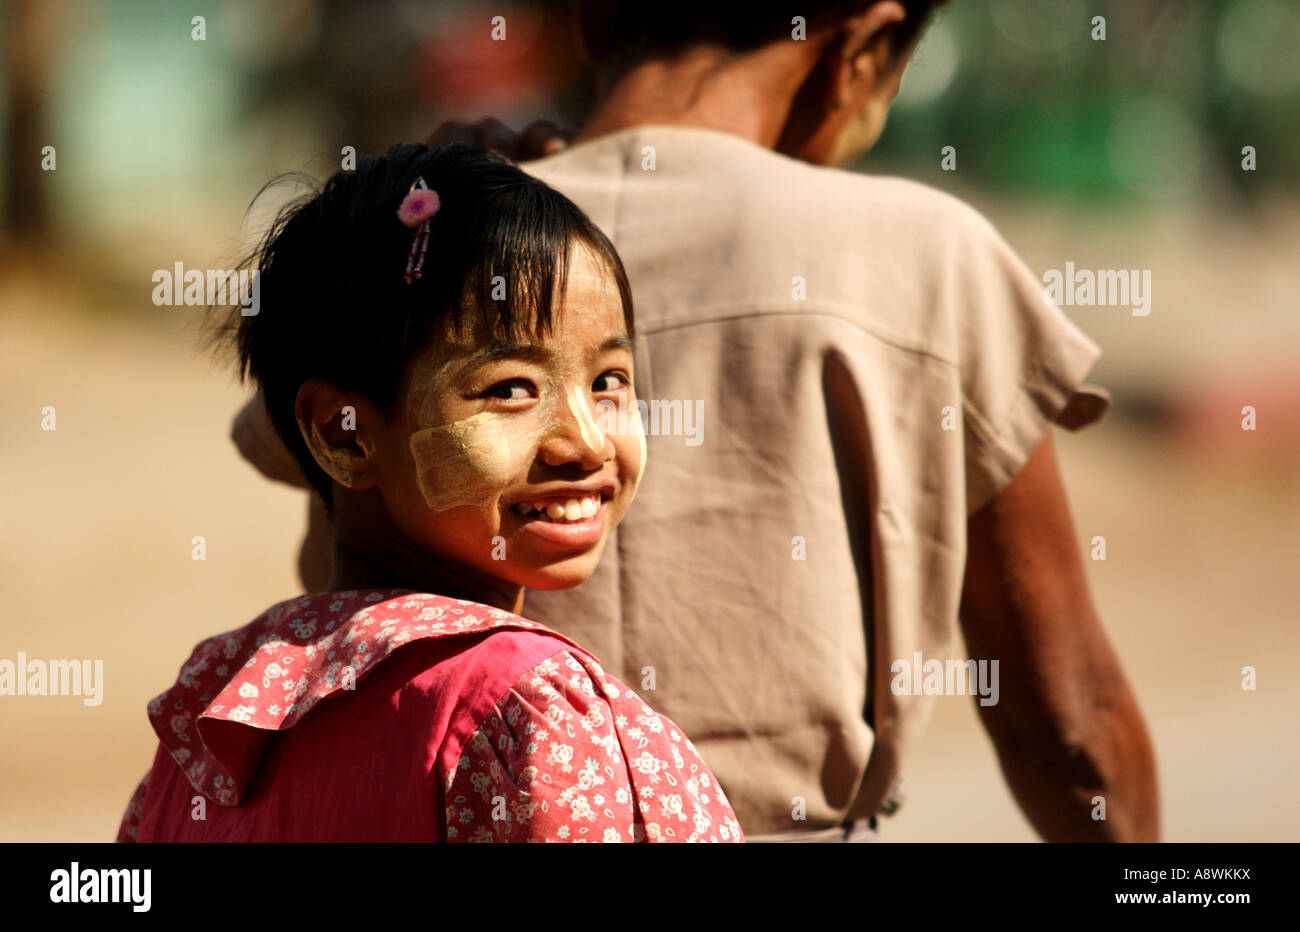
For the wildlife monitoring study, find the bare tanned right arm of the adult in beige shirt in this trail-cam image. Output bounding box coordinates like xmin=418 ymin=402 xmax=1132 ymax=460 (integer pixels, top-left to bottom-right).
xmin=961 ymin=434 xmax=1160 ymax=841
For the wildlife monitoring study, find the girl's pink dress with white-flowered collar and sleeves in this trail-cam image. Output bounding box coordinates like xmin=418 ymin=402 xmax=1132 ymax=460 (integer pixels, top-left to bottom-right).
xmin=117 ymin=590 xmax=744 ymax=842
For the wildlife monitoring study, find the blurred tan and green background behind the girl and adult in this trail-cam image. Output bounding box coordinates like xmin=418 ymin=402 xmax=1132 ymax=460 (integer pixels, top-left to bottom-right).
xmin=0 ymin=0 xmax=1300 ymax=841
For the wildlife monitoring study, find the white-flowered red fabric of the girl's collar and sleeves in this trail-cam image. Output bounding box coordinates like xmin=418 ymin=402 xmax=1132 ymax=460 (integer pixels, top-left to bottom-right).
xmin=117 ymin=590 xmax=744 ymax=842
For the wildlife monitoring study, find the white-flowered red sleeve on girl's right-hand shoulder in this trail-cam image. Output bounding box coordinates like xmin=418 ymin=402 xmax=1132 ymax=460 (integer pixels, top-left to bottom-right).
xmin=446 ymin=650 xmax=744 ymax=842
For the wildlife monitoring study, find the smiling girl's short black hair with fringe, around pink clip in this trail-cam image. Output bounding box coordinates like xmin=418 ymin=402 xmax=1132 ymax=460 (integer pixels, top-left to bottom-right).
xmin=216 ymin=144 xmax=634 ymax=503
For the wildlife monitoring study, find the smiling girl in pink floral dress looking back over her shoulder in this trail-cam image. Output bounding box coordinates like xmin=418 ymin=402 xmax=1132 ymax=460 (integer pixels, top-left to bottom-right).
xmin=118 ymin=139 xmax=744 ymax=841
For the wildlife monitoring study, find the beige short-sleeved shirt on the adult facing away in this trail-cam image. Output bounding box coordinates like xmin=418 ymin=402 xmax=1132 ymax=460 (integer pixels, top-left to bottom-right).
xmin=524 ymin=126 xmax=1109 ymax=835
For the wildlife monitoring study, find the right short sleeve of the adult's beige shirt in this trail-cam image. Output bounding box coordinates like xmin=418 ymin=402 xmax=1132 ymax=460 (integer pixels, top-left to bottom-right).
xmin=946 ymin=205 xmax=1110 ymax=512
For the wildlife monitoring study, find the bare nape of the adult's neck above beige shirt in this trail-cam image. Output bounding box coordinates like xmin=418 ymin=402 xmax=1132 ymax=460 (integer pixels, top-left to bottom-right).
xmin=573 ymin=47 xmax=806 ymax=148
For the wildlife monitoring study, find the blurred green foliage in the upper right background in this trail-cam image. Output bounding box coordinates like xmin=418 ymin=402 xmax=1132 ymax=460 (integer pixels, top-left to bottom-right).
xmin=865 ymin=0 xmax=1300 ymax=207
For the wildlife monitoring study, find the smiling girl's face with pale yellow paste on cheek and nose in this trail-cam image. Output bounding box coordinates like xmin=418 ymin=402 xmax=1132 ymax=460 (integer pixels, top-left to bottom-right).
xmin=376 ymin=244 xmax=646 ymax=589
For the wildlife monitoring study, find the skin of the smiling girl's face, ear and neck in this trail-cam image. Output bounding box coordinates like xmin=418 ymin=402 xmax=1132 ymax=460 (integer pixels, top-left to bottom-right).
xmin=298 ymin=246 xmax=645 ymax=612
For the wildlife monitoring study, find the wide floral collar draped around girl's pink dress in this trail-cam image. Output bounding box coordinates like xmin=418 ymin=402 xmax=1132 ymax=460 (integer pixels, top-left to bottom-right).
xmin=148 ymin=589 xmax=589 ymax=806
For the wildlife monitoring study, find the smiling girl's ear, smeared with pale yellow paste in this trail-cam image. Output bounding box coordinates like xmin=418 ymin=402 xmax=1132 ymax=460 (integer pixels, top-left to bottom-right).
xmin=294 ymin=378 xmax=384 ymax=491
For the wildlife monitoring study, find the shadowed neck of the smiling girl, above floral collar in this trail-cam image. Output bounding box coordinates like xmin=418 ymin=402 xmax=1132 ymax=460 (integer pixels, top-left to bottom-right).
xmin=330 ymin=486 xmax=524 ymax=615
